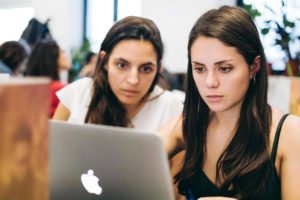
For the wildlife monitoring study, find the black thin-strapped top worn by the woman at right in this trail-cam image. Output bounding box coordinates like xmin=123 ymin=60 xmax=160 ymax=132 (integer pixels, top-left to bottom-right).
xmin=179 ymin=114 xmax=288 ymax=200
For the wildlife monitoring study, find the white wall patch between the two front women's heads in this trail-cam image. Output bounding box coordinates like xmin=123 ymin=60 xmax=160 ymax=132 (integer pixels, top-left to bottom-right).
xmin=141 ymin=0 xmax=235 ymax=73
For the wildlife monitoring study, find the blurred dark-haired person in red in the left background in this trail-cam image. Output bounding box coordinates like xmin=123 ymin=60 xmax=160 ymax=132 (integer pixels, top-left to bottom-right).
xmin=25 ymin=40 xmax=71 ymax=118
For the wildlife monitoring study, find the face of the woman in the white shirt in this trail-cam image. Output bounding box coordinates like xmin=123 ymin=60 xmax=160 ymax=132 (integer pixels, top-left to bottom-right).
xmin=105 ymin=40 xmax=157 ymax=109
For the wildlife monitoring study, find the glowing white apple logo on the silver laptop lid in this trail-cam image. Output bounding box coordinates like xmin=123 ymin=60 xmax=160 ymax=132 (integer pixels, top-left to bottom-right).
xmin=81 ymin=169 xmax=102 ymax=195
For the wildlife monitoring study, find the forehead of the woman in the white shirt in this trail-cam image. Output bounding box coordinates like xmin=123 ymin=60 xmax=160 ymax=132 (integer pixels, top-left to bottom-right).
xmin=110 ymin=40 xmax=157 ymax=62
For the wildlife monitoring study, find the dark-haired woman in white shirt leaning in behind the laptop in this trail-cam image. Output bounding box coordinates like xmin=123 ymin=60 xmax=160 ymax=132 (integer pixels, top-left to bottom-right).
xmin=54 ymin=16 xmax=183 ymax=131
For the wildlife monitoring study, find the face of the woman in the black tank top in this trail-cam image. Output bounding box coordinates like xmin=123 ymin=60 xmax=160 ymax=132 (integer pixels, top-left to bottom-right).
xmin=191 ymin=36 xmax=252 ymax=112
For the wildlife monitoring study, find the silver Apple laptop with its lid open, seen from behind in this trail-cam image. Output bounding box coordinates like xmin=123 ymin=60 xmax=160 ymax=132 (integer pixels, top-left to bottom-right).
xmin=49 ymin=120 xmax=174 ymax=200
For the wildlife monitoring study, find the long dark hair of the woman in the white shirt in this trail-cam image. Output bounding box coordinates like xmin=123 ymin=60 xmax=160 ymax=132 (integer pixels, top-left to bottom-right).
xmin=85 ymin=16 xmax=163 ymax=127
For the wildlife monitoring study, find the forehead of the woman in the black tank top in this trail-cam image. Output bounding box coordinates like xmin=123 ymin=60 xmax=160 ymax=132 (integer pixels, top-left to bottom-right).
xmin=190 ymin=36 xmax=244 ymax=62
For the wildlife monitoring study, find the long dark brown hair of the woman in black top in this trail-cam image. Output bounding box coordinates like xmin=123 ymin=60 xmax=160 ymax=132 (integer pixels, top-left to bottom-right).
xmin=175 ymin=6 xmax=272 ymax=199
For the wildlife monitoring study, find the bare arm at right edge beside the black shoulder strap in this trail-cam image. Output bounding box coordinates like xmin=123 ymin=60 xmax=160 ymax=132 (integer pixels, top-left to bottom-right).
xmin=279 ymin=115 xmax=300 ymax=200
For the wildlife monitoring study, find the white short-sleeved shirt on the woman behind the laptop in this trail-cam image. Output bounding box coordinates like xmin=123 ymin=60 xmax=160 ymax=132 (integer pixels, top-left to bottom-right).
xmin=56 ymin=78 xmax=183 ymax=132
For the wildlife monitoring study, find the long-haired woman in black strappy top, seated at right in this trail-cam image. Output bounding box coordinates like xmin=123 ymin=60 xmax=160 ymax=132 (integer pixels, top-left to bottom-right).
xmin=161 ymin=6 xmax=300 ymax=200
